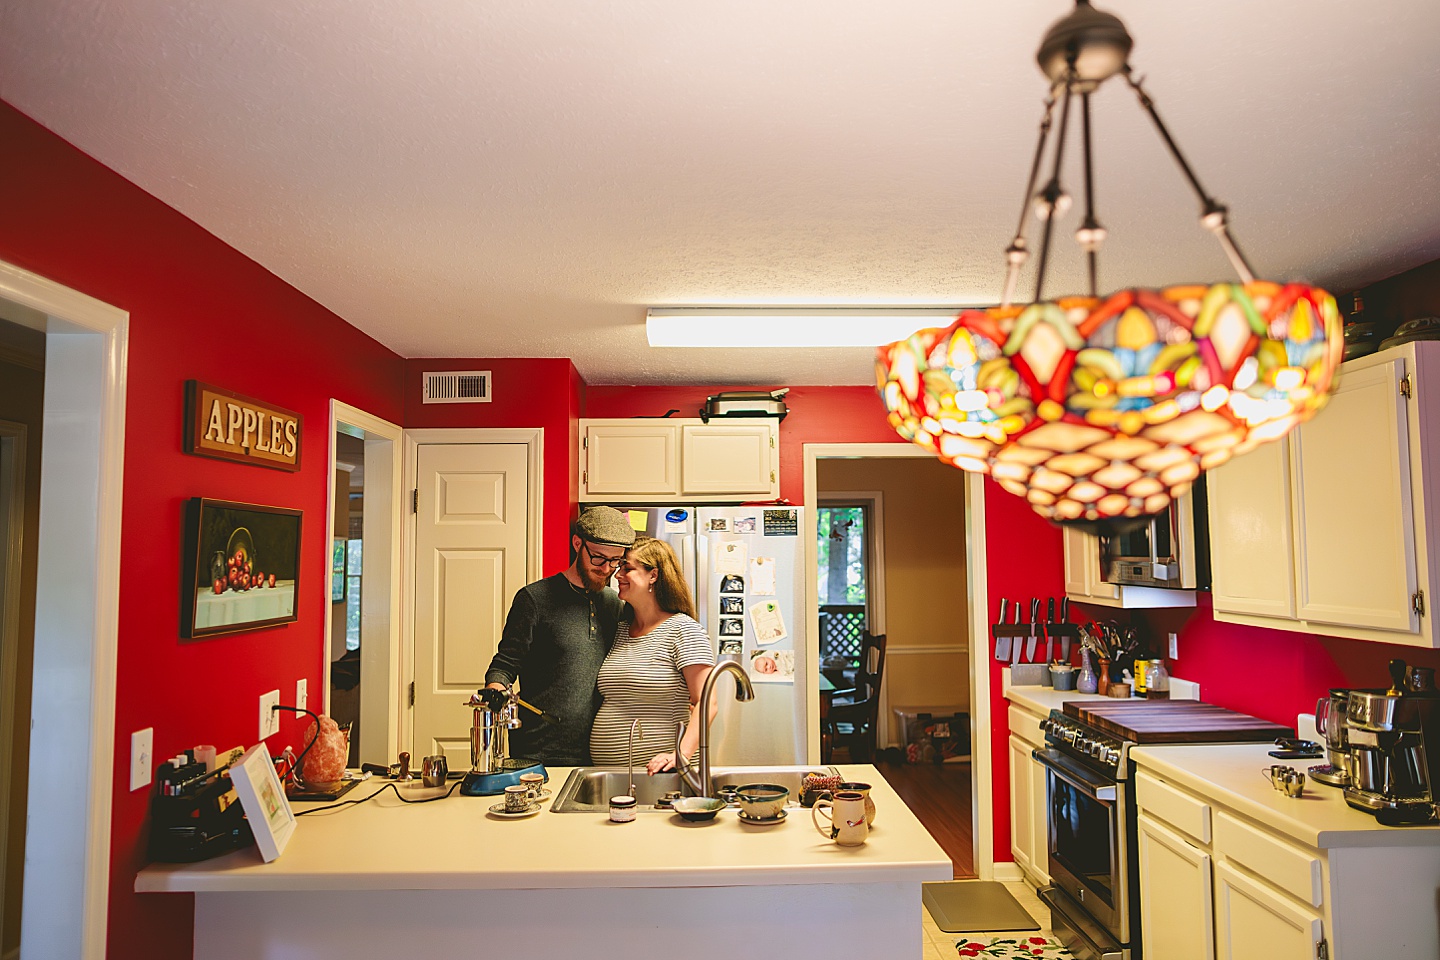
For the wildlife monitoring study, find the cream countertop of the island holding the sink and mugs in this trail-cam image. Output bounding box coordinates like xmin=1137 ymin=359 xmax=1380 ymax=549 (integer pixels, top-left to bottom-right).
xmin=135 ymin=766 xmax=953 ymax=892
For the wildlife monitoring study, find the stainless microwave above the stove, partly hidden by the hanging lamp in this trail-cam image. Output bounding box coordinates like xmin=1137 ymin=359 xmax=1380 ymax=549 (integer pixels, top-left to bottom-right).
xmin=1099 ymin=474 xmax=1210 ymax=590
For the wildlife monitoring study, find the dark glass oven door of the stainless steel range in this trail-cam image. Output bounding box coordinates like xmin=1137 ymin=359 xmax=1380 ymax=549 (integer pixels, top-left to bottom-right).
xmin=1032 ymin=748 xmax=1130 ymax=944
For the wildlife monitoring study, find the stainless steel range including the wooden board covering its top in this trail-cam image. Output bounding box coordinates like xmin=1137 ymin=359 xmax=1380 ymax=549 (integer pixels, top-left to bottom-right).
xmin=1032 ymin=701 xmax=1292 ymax=960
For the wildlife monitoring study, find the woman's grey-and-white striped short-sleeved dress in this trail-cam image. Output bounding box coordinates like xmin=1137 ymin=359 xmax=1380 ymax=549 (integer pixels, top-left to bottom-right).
xmin=590 ymin=613 xmax=716 ymax=764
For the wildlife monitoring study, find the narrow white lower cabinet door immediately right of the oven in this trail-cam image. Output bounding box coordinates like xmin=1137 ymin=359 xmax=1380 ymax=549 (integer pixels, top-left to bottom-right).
xmin=1139 ymin=815 xmax=1215 ymax=960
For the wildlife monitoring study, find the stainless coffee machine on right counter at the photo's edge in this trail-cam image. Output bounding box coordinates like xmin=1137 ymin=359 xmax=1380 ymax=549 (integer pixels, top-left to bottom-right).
xmin=1345 ymin=661 xmax=1440 ymax=826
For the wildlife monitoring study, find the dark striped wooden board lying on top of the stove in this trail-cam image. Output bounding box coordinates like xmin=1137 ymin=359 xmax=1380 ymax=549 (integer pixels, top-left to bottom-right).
xmin=1064 ymin=699 xmax=1295 ymax=743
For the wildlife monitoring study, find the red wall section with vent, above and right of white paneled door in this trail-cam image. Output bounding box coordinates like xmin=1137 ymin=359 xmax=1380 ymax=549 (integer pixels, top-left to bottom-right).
xmin=405 ymin=357 xmax=585 ymax=569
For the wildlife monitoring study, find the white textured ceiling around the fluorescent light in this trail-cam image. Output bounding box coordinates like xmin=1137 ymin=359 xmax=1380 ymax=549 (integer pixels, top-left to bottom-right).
xmin=0 ymin=0 xmax=1440 ymax=384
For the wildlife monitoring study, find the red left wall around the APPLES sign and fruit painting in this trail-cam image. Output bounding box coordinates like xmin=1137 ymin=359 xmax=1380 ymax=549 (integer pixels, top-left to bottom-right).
xmin=0 ymin=104 xmax=405 ymax=957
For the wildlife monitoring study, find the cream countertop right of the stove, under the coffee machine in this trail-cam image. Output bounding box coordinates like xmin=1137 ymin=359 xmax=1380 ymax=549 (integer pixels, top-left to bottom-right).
xmin=1130 ymin=743 xmax=1440 ymax=849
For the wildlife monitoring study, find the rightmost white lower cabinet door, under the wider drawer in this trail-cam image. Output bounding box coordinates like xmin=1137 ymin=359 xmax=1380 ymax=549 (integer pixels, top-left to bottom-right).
xmin=1209 ymin=862 xmax=1319 ymax=960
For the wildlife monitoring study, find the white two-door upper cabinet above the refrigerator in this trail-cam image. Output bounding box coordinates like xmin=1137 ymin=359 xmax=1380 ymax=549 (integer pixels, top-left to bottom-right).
xmin=580 ymin=419 xmax=780 ymax=502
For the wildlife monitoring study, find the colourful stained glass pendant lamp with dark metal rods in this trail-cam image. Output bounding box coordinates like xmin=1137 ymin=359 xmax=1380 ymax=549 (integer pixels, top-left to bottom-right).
xmin=876 ymin=0 xmax=1345 ymax=533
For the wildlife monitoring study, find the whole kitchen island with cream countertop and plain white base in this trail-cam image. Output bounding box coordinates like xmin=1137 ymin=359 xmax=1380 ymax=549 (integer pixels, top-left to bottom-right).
xmin=135 ymin=766 xmax=953 ymax=960
